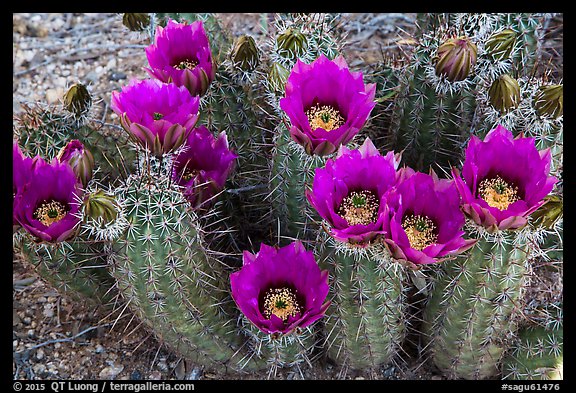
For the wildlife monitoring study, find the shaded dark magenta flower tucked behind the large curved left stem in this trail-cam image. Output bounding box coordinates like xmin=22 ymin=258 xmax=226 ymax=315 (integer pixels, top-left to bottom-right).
xmin=172 ymin=126 xmax=238 ymax=208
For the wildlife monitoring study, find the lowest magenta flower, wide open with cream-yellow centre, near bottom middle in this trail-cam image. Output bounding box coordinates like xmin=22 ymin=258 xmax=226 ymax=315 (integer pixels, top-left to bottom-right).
xmin=230 ymin=241 xmax=330 ymax=334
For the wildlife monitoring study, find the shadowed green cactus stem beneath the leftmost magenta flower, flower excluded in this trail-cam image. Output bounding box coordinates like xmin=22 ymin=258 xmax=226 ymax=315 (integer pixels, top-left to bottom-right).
xmin=14 ymin=235 xmax=117 ymax=306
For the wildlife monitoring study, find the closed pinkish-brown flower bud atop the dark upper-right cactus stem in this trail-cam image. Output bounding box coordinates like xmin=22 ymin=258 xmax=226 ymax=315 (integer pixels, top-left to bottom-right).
xmin=434 ymin=36 xmax=478 ymax=82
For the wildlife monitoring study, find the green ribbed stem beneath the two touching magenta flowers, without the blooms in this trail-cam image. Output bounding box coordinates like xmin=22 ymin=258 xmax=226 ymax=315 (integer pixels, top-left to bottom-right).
xmin=319 ymin=235 xmax=408 ymax=375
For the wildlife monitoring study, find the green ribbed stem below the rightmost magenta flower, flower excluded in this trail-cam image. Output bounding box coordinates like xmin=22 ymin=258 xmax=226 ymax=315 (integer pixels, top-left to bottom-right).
xmin=423 ymin=233 xmax=528 ymax=379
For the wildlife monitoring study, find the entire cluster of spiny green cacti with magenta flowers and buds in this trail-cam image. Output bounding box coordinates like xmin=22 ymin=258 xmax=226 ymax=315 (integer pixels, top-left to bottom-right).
xmin=13 ymin=13 xmax=563 ymax=379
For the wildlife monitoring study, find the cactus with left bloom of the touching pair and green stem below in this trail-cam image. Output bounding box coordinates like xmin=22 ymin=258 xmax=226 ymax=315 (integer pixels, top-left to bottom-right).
xmin=307 ymin=139 xmax=406 ymax=372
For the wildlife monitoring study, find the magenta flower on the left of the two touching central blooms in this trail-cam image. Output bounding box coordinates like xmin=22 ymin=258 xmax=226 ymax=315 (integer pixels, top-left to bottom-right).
xmin=306 ymin=138 xmax=400 ymax=245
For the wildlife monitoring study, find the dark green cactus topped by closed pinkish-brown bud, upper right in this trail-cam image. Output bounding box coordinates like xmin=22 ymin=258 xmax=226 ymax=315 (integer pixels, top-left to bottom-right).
xmin=372 ymin=16 xmax=481 ymax=171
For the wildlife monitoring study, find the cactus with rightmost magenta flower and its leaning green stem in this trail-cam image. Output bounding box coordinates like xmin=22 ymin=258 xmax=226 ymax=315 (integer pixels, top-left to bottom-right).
xmin=423 ymin=126 xmax=557 ymax=379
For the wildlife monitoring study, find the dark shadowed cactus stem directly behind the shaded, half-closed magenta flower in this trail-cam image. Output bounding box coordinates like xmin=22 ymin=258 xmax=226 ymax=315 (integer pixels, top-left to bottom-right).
xmin=199 ymin=59 xmax=272 ymax=249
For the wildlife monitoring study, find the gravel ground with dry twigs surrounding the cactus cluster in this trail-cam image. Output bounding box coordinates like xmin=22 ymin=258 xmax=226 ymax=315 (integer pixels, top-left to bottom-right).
xmin=13 ymin=13 xmax=561 ymax=380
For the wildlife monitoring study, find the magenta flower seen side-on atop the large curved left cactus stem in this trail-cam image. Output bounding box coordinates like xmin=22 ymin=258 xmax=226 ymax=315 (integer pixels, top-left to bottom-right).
xmin=110 ymin=79 xmax=200 ymax=156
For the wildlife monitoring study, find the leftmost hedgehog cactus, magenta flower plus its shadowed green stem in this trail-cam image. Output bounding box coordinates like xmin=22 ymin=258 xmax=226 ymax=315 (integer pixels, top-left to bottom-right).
xmin=13 ymin=141 xmax=120 ymax=306
